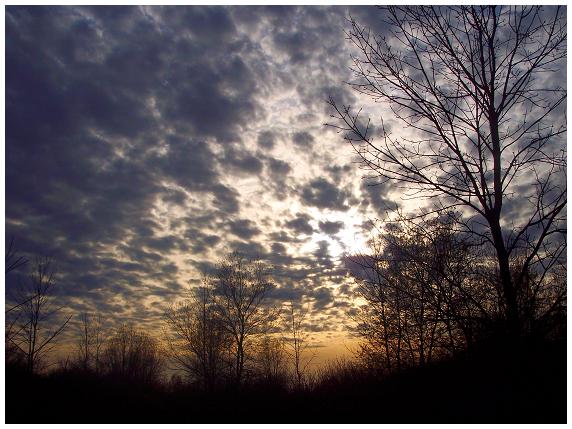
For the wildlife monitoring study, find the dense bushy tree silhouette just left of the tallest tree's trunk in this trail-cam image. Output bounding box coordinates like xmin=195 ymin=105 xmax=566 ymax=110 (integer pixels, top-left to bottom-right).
xmin=351 ymin=217 xmax=494 ymax=370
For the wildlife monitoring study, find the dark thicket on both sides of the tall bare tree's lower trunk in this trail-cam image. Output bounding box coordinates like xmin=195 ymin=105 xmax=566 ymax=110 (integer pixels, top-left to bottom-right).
xmin=349 ymin=212 xmax=566 ymax=372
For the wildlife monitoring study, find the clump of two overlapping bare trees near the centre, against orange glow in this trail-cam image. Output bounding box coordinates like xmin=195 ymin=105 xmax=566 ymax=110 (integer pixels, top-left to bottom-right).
xmin=166 ymin=253 xmax=280 ymax=389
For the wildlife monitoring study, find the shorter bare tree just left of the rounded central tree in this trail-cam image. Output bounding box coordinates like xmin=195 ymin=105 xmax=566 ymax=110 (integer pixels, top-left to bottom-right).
xmin=165 ymin=281 xmax=231 ymax=389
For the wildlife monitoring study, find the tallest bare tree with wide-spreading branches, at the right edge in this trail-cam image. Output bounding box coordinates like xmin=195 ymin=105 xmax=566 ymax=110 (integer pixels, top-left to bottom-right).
xmin=330 ymin=6 xmax=566 ymax=334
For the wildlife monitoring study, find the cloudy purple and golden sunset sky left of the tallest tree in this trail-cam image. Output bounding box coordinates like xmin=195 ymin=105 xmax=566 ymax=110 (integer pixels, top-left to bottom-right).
xmin=5 ymin=6 xmax=399 ymax=357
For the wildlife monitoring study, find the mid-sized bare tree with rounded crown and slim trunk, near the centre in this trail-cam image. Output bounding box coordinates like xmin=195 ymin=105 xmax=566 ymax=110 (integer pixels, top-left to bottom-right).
xmin=208 ymin=252 xmax=278 ymax=384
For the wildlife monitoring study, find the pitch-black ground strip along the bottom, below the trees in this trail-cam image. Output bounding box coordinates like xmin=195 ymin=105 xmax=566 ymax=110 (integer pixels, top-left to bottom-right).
xmin=6 ymin=341 xmax=566 ymax=423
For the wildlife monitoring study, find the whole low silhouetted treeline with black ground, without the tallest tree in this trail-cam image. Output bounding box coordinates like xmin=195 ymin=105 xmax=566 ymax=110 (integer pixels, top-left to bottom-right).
xmin=6 ymin=231 xmax=566 ymax=423
